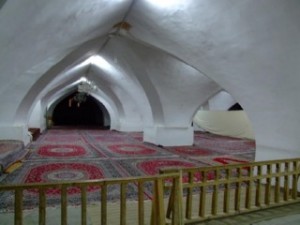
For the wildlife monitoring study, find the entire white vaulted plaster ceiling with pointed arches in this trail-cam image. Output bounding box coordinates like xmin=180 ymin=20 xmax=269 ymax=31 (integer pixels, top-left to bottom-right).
xmin=0 ymin=0 xmax=300 ymax=158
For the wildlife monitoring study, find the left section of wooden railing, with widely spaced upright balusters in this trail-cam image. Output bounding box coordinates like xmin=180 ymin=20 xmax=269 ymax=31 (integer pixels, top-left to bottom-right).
xmin=0 ymin=173 xmax=182 ymax=225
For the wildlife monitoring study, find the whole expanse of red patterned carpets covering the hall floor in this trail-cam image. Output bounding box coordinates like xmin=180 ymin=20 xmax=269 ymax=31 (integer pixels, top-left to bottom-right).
xmin=0 ymin=129 xmax=255 ymax=210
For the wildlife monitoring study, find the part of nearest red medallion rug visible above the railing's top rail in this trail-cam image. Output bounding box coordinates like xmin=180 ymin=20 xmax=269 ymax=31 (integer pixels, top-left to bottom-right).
xmin=2 ymin=159 xmax=123 ymax=184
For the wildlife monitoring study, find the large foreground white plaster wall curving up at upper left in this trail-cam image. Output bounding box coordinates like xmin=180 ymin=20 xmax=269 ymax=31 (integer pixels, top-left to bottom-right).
xmin=0 ymin=0 xmax=131 ymax=141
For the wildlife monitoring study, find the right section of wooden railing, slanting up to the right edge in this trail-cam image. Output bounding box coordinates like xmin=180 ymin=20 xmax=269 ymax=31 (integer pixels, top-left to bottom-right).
xmin=161 ymin=158 xmax=300 ymax=224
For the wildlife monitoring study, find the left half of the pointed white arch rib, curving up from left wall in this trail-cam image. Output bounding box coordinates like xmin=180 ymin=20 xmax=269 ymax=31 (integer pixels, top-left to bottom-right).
xmin=14 ymin=38 xmax=109 ymax=123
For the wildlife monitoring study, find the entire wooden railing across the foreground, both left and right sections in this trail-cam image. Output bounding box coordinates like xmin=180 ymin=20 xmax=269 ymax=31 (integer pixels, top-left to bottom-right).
xmin=0 ymin=158 xmax=300 ymax=225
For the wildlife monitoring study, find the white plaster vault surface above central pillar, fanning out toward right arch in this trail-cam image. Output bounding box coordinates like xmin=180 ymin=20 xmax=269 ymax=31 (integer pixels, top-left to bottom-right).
xmin=113 ymin=36 xmax=220 ymax=127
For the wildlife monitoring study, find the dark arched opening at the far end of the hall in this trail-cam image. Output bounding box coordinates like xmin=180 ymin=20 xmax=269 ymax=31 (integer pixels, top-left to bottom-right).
xmin=52 ymin=92 xmax=109 ymax=129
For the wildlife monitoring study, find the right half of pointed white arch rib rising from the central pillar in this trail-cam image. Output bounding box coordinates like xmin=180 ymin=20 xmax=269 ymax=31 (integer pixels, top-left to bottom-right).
xmin=106 ymin=36 xmax=164 ymax=127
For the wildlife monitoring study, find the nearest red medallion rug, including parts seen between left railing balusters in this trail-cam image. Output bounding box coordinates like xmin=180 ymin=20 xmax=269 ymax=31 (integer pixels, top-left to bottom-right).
xmin=0 ymin=160 xmax=130 ymax=211
